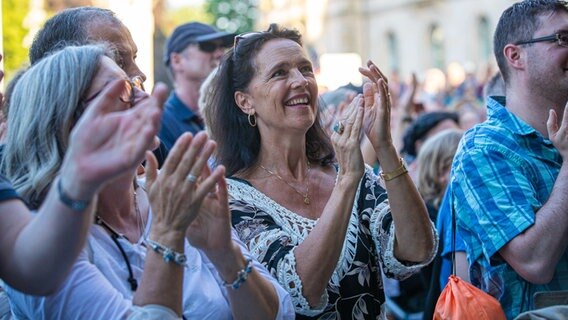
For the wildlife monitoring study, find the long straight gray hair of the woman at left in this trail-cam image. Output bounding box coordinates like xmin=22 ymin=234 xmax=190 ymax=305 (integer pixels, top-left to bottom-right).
xmin=0 ymin=45 xmax=108 ymax=208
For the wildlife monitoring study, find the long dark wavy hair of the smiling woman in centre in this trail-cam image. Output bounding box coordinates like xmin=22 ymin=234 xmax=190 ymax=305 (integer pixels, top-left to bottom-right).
xmin=204 ymin=24 xmax=335 ymax=176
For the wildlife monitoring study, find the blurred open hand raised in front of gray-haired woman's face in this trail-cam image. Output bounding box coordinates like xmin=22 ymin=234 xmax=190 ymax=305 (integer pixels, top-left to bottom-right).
xmin=61 ymin=80 xmax=167 ymax=199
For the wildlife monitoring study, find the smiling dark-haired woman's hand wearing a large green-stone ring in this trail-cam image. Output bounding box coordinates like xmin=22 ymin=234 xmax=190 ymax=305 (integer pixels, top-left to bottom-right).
xmin=331 ymin=95 xmax=365 ymax=180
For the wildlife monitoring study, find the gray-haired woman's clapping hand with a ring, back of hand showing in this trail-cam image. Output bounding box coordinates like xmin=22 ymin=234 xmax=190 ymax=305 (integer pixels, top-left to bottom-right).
xmin=146 ymin=132 xmax=223 ymax=237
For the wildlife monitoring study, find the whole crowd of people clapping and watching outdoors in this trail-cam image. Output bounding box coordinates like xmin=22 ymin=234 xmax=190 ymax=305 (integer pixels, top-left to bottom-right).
xmin=0 ymin=0 xmax=568 ymax=319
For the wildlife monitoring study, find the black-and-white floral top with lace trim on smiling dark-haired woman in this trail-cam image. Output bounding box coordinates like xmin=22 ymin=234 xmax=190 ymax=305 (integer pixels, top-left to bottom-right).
xmin=228 ymin=168 xmax=436 ymax=319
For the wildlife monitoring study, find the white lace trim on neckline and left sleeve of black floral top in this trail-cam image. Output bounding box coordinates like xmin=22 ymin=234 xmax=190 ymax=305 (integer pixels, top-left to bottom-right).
xmin=228 ymin=172 xmax=369 ymax=316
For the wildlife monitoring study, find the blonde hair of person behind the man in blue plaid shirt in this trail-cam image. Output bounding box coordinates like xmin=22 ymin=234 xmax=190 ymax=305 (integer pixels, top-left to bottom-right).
xmin=417 ymin=129 xmax=463 ymax=207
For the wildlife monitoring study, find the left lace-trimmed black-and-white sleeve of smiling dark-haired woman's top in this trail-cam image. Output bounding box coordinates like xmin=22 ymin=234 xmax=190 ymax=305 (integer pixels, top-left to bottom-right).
xmin=230 ymin=200 xmax=328 ymax=316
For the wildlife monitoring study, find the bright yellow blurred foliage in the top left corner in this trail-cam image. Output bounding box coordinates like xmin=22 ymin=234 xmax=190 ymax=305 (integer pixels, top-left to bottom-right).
xmin=1 ymin=0 xmax=29 ymax=81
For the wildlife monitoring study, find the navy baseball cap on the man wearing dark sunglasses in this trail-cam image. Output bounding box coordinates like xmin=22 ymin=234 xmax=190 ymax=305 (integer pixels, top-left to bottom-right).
xmin=164 ymin=22 xmax=235 ymax=66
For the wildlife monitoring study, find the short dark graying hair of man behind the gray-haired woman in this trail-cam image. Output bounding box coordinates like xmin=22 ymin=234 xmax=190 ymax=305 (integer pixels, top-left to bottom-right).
xmin=29 ymin=7 xmax=118 ymax=64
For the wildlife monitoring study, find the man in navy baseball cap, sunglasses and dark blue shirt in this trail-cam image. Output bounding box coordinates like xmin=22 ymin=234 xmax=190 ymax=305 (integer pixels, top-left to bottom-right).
xmin=159 ymin=22 xmax=235 ymax=157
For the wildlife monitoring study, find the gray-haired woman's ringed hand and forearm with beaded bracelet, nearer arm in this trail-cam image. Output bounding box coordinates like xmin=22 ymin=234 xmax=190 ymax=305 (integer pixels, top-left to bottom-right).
xmin=133 ymin=132 xmax=224 ymax=315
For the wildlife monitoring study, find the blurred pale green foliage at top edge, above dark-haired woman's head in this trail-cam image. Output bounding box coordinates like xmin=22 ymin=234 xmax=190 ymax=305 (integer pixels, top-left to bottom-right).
xmin=205 ymin=0 xmax=257 ymax=33
